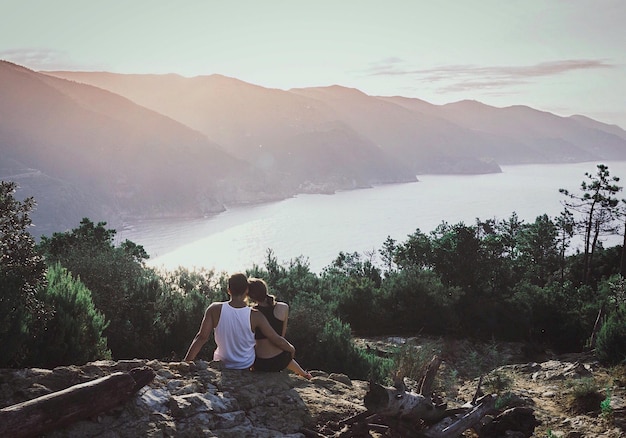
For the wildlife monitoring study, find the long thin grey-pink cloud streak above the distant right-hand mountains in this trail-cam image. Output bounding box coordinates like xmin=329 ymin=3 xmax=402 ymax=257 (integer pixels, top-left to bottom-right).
xmin=366 ymin=58 xmax=616 ymax=92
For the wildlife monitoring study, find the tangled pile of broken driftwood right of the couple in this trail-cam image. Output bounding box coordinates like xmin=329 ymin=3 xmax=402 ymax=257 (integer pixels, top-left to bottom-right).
xmin=334 ymin=356 xmax=538 ymax=438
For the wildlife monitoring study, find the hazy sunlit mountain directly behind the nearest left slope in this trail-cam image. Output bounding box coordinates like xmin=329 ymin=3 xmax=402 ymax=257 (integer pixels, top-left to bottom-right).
xmin=41 ymin=72 xmax=416 ymax=191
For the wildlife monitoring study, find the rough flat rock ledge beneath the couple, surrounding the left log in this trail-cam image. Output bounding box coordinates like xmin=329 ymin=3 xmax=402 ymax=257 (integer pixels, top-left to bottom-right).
xmin=0 ymin=360 xmax=327 ymax=438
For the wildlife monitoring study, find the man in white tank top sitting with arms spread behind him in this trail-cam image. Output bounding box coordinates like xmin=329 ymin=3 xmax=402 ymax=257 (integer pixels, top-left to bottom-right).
xmin=184 ymin=273 xmax=296 ymax=370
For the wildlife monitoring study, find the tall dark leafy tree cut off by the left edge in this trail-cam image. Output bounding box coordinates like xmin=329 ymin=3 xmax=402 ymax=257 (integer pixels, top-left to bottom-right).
xmin=0 ymin=181 xmax=50 ymax=367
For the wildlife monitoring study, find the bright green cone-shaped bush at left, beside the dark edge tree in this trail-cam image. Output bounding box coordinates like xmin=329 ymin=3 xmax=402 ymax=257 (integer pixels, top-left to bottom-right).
xmin=29 ymin=263 xmax=111 ymax=368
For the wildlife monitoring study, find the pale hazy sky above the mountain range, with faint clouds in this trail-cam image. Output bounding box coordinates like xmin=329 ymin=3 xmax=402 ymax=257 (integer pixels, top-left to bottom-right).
xmin=0 ymin=0 xmax=626 ymax=129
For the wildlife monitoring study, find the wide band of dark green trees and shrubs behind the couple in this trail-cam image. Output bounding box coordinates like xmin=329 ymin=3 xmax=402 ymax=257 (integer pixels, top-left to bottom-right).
xmin=7 ymin=165 xmax=626 ymax=372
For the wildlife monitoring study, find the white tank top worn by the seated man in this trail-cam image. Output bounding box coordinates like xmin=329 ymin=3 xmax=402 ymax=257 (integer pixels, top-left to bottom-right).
xmin=213 ymin=303 xmax=255 ymax=370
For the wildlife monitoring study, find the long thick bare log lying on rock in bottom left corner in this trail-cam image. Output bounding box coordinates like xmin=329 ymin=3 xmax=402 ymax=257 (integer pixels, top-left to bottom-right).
xmin=0 ymin=367 xmax=155 ymax=438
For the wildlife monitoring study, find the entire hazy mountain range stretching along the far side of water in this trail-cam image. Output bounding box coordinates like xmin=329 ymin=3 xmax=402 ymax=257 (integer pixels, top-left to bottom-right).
xmin=0 ymin=61 xmax=626 ymax=233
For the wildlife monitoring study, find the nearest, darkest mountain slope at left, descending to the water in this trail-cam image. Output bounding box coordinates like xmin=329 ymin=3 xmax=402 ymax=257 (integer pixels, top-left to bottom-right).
xmin=0 ymin=62 xmax=284 ymax=235
